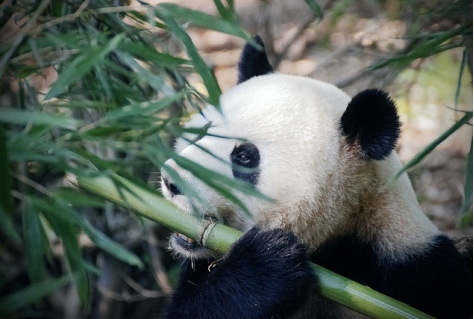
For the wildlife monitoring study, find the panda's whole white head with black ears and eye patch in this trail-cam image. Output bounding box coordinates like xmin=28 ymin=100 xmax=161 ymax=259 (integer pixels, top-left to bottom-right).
xmin=162 ymin=37 xmax=400 ymax=259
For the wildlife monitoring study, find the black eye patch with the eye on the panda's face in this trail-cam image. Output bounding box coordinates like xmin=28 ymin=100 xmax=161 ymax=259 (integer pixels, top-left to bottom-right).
xmin=230 ymin=143 xmax=260 ymax=185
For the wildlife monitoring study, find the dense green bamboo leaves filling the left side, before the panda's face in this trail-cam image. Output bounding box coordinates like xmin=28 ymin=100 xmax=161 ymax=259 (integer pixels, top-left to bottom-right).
xmin=0 ymin=0 xmax=258 ymax=314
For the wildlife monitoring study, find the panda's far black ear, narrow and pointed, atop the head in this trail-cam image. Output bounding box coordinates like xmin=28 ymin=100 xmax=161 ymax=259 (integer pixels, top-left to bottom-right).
xmin=237 ymin=35 xmax=274 ymax=84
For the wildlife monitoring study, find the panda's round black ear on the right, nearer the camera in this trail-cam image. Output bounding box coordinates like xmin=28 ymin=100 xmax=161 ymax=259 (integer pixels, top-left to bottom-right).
xmin=341 ymin=89 xmax=400 ymax=160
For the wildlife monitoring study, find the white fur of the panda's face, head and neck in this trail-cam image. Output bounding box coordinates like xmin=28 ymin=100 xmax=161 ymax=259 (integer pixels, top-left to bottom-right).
xmin=163 ymin=74 xmax=437 ymax=258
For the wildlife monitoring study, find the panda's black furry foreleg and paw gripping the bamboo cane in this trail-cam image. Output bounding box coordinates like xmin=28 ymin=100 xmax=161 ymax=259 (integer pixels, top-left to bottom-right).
xmin=167 ymin=228 xmax=315 ymax=319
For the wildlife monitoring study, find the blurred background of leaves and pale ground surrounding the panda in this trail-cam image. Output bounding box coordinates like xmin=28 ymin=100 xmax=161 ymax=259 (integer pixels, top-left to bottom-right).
xmin=0 ymin=0 xmax=472 ymax=319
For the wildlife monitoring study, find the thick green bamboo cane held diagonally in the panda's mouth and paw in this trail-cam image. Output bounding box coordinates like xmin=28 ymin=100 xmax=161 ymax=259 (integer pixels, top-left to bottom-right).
xmin=69 ymin=174 xmax=432 ymax=318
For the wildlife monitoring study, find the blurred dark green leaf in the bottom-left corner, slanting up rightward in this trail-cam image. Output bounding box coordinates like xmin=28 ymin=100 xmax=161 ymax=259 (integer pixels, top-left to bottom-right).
xmin=0 ymin=275 xmax=71 ymax=315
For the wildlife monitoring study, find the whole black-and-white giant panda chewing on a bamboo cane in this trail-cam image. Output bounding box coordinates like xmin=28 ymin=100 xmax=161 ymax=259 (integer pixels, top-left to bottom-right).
xmin=162 ymin=37 xmax=472 ymax=318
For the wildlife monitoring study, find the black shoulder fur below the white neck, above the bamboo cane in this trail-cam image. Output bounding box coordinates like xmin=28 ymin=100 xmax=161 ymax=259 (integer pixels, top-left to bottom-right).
xmin=311 ymin=235 xmax=472 ymax=318
